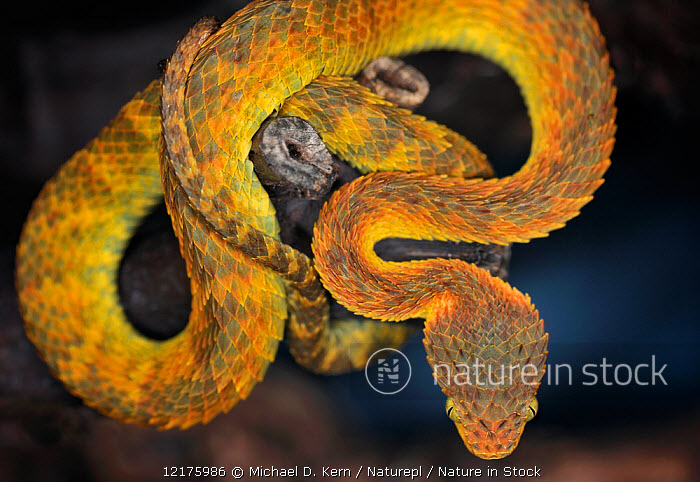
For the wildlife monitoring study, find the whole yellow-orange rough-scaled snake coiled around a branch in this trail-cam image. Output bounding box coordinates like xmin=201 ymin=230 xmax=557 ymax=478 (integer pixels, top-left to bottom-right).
xmin=16 ymin=0 xmax=616 ymax=459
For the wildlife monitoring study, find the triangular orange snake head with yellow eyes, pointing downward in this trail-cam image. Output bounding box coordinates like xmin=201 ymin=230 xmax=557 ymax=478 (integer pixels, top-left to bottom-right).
xmin=424 ymin=275 xmax=548 ymax=459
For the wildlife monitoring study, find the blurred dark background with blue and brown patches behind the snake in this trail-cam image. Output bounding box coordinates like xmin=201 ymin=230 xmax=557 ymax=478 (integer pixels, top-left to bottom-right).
xmin=0 ymin=0 xmax=700 ymax=481
